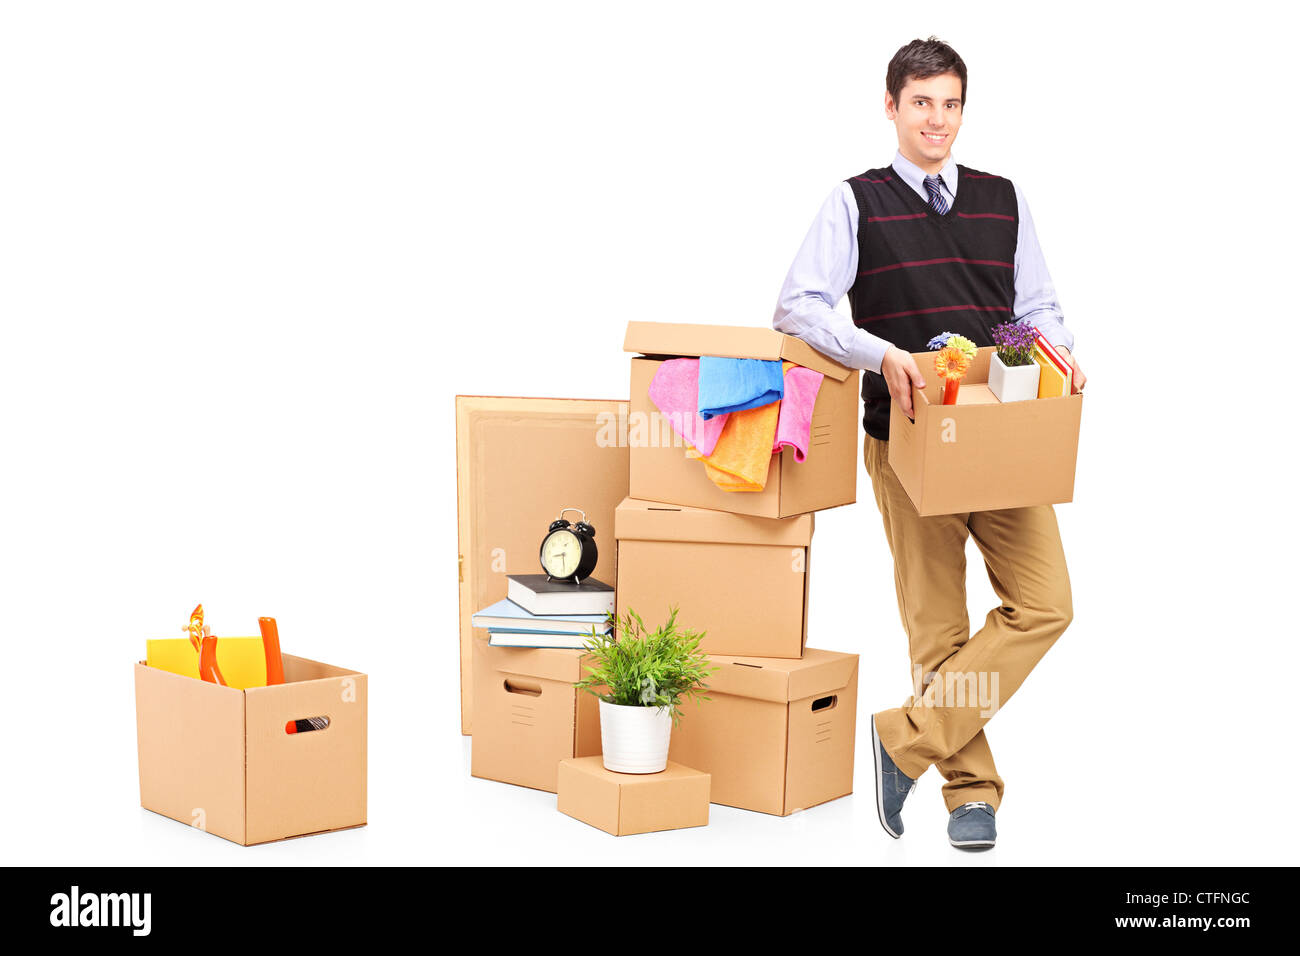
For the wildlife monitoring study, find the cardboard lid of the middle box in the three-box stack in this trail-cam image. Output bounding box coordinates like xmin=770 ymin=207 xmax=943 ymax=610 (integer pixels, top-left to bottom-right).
xmin=614 ymin=498 xmax=813 ymax=548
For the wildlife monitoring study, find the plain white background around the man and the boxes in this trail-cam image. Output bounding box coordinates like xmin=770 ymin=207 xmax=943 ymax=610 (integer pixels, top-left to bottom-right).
xmin=0 ymin=1 xmax=1297 ymax=866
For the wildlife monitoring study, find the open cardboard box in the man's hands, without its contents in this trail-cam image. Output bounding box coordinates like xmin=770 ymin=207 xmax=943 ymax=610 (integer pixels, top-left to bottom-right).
xmin=889 ymin=347 xmax=1083 ymax=515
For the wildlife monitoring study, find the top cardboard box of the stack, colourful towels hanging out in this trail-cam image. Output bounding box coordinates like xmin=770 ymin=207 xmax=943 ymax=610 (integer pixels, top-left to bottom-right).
xmin=623 ymin=323 xmax=859 ymax=518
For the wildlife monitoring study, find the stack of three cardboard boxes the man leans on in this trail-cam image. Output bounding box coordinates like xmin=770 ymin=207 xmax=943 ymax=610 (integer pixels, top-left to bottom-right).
xmin=615 ymin=323 xmax=858 ymax=816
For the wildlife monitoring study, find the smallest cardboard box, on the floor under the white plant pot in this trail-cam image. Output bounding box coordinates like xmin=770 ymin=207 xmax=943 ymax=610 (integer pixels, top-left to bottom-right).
xmin=555 ymin=757 xmax=709 ymax=836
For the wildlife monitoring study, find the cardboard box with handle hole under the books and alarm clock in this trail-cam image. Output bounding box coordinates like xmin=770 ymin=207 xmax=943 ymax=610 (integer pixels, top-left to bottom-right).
xmin=469 ymin=635 xmax=601 ymax=793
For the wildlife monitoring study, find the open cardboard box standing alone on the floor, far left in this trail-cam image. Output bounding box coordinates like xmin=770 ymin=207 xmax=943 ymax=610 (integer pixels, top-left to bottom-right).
xmin=135 ymin=654 xmax=367 ymax=845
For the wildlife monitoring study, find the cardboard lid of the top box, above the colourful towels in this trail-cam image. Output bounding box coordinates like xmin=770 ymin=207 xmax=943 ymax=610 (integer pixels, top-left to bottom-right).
xmin=623 ymin=323 xmax=853 ymax=381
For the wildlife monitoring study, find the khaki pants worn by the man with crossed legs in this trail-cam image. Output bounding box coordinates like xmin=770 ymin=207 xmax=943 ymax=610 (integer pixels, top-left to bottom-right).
xmin=862 ymin=434 xmax=1074 ymax=812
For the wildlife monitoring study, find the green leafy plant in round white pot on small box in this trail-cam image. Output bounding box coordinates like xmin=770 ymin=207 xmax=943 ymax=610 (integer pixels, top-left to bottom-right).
xmin=573 ymin=607 xmax=718 ymax=774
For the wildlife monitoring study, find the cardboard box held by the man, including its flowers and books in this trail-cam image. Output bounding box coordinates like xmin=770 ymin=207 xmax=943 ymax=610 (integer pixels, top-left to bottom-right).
xmin=889 ymin=326 xmax=1083 ymax=515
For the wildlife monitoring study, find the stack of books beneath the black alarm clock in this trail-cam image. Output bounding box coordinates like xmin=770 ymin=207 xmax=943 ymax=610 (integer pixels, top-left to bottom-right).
xmin=471 ymin=575 xmax=614 ymax=648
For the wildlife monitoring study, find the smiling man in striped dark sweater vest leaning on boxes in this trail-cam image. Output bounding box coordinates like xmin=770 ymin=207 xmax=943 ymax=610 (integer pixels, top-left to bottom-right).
xmin=772 ymin=36 xmax=1086 ymax=849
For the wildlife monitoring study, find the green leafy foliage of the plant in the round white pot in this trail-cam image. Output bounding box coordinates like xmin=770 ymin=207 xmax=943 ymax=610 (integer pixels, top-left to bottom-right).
xmin=573 ymin=607 xmax=718 ymax=726
